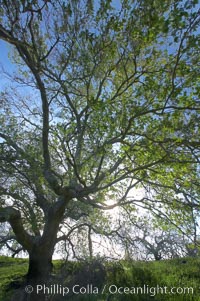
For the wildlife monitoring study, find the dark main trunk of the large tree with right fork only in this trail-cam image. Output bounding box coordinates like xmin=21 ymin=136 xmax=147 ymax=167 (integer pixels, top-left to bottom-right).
xmin=23 ymin=198 xmax=69 ymax=301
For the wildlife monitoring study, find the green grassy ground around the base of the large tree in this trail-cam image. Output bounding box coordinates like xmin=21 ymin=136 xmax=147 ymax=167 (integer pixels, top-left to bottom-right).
xmin=0 ymin=256 xmax=200 ymax=301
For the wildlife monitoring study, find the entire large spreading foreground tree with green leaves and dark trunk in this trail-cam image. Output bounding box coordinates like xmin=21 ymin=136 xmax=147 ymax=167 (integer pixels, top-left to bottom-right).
xmin=0 ymin=0 xmax=200 ymax=301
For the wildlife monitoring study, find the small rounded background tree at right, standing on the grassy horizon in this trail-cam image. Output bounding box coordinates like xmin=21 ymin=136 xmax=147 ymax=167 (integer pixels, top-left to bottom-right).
xmin=117 ymin=215 xmax=187 ymax=260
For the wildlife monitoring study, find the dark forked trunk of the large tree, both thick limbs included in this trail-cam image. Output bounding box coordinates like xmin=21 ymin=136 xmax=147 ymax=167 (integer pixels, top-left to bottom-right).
xmin=0 ymin=196 xmax=70 ymax=301
